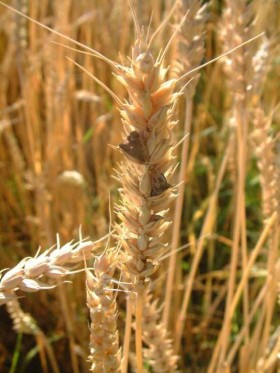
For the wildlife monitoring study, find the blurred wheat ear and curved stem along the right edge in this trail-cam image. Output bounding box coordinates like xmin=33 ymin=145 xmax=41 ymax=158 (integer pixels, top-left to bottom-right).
xmin=252 ymin=106 xmax=279 ymax=366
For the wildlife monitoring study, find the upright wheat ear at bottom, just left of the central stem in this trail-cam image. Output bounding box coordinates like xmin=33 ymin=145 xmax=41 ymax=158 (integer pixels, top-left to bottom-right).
xmin=86 ymin=252 xmax=121 ymax=373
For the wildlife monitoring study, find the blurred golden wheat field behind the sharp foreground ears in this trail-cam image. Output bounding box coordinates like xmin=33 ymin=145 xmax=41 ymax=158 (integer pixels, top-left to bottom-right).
xmin=0 ymin=0 xmax=280 ymax=373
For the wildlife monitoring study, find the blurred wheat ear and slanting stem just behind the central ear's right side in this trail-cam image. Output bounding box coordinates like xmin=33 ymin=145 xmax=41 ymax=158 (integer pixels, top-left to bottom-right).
xmin=163 ymin=0 xmax=207 ymax=326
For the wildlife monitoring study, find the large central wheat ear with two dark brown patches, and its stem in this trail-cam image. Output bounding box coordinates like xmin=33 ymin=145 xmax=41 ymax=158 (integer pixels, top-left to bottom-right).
xmin=113 ymin=18 xmax=182 ymax=373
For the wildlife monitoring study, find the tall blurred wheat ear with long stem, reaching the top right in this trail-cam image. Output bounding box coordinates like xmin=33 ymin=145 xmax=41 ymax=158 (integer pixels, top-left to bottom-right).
xmin=215 ymin=0 xmax=268 ymax=369
